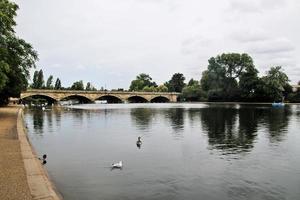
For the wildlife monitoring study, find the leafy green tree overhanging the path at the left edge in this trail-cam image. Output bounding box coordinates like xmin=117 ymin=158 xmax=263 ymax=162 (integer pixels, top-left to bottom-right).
xmin=0 ymin=0 xmax=38 ymax=104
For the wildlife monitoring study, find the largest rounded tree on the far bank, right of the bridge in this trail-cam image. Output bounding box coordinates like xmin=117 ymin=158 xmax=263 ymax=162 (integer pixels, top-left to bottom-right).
xmin=201 ymin=53 xmax=258 ymax=101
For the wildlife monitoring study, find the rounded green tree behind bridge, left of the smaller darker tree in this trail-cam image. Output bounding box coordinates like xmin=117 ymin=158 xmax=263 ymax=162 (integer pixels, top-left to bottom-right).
xmin=129 ymin=73 xmax=157 ymax=91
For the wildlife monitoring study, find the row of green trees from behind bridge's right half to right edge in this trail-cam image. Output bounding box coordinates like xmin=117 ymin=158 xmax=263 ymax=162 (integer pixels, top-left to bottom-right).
xmin=129 ymin=53 xmax=300 ymax=102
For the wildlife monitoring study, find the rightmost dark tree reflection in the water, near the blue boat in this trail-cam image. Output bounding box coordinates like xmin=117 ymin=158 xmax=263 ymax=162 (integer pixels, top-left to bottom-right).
xmin=265 ymin=106 xmax=292 ymax=142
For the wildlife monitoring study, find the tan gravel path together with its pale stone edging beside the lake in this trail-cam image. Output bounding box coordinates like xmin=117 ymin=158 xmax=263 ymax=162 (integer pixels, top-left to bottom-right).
xmin=0 ymin=106 xmax=62 ymax=200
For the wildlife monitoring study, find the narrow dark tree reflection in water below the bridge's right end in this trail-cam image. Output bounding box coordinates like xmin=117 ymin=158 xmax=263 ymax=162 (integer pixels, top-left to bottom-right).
xmin=165 ymin=108 xmax=184 ymax=132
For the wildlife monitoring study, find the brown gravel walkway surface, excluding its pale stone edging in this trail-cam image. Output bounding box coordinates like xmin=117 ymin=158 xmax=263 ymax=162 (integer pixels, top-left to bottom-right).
xmin=0 ymin=107 xmax=32 ymax=200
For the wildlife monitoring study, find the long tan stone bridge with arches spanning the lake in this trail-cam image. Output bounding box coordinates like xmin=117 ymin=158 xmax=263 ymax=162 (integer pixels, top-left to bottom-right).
xmin=21 ymin=89 xmax=179 ymax=103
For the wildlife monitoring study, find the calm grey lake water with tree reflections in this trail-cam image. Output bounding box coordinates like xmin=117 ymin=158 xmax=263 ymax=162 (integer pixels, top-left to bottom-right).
xmin=25 ymin=104 xmax=300 ymax=200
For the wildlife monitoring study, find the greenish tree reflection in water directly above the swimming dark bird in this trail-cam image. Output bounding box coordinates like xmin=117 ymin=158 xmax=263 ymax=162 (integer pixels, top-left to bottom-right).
xmin=130 ymin=108 xmax=155 ymax=130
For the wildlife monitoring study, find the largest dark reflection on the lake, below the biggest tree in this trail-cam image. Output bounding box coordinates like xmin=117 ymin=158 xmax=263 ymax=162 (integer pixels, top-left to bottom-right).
xmin=201 ymin=107 xmax=258 ymax=153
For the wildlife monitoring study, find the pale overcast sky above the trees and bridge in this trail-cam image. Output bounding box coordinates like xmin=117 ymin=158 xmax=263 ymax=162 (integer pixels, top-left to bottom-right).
xmin=15 ymin=0 xmax=300 ymax=89
